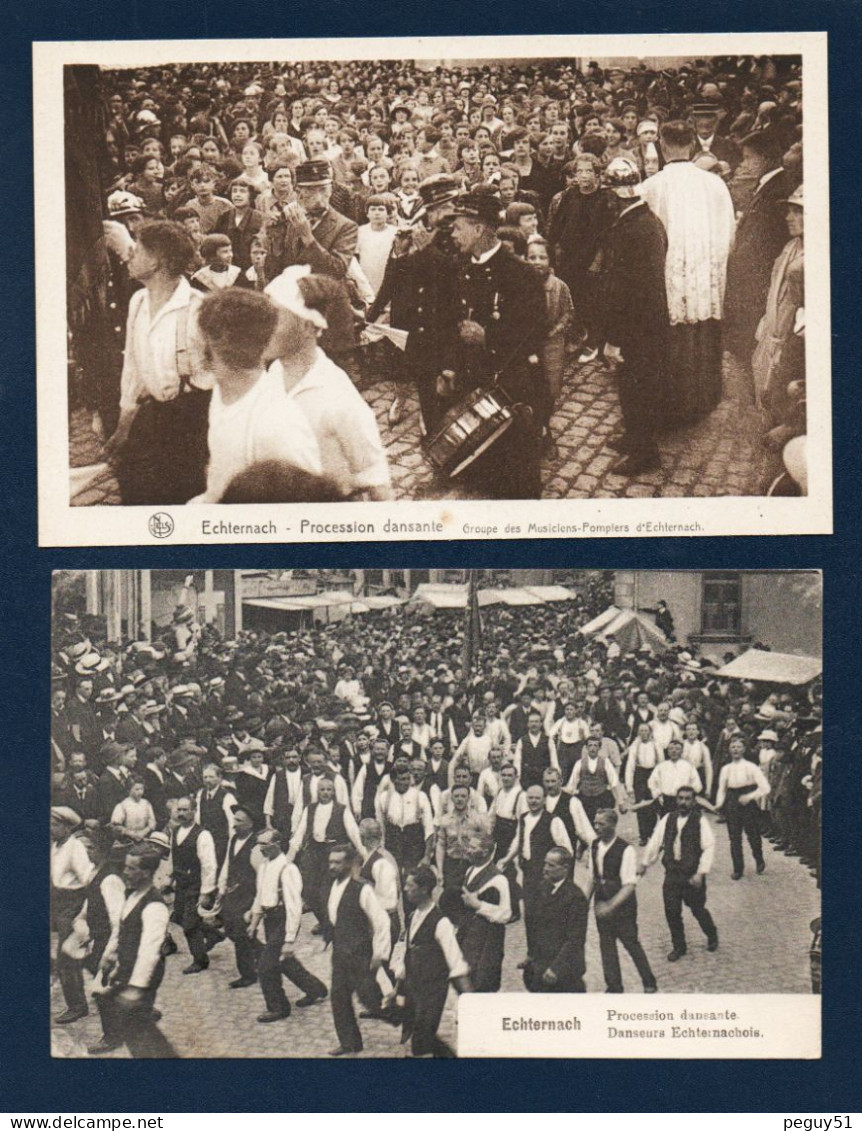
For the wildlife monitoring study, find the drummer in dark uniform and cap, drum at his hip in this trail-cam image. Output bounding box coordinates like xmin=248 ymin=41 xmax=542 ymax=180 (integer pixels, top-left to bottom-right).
xmin=451 ymin=190 xmax=549 ymax=499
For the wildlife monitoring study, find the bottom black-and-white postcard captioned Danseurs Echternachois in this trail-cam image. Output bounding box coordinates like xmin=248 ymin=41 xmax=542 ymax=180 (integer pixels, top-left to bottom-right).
xmin=50 ymin=569 xmax=822 ymax=1059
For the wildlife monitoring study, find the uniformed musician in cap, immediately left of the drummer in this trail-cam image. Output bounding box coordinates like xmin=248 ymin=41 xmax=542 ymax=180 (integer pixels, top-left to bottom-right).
xmin=368 ymin=173 xmax=460 ymax=437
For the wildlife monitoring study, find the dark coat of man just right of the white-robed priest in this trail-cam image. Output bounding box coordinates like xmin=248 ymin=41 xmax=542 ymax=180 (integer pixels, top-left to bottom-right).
xmin=724 ymin=170 xmax=791 ymax=352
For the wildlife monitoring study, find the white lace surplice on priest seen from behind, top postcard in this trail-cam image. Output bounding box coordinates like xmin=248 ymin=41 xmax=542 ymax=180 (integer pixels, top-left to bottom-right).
xmin=640 ymin=161 xmax=735 ymax=326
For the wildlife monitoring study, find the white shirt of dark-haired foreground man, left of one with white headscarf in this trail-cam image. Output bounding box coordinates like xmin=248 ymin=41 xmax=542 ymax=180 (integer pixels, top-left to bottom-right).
xmin=191 ymin=372 xmax=320 ymax=503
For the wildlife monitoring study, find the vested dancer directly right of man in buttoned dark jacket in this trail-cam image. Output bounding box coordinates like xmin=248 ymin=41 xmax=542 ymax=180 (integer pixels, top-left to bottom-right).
xmin=589 ymin=809 xmax=656 ymax=993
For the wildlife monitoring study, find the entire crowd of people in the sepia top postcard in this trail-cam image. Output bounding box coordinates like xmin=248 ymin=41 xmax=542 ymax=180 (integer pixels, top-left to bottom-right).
xmin=72 ymin=48 xmax=805 ymax=503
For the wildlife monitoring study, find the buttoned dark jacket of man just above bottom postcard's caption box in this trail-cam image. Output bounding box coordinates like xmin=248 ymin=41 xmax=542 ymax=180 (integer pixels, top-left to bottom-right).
xmin=527 ymin=880 xmax=589 ymax=993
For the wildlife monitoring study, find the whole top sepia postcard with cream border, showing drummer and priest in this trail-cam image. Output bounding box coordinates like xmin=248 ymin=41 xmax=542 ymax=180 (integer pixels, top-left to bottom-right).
xmin=34 ymin=33 xmax=833 ymax=545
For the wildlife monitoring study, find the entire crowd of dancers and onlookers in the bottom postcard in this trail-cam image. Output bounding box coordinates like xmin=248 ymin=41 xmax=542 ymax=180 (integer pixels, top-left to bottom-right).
xmin=51 ymin=580 xmax=822 ymax=1056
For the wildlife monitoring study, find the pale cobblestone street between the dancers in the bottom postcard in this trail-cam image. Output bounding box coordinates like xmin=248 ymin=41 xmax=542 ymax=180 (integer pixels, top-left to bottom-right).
xmin=51 ymin=814 xmax=820 ymax=1057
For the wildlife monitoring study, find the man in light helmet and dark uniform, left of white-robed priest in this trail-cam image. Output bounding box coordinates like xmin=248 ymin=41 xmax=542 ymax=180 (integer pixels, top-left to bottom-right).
xmin=604 ymin=157 xmax=670 ymax=475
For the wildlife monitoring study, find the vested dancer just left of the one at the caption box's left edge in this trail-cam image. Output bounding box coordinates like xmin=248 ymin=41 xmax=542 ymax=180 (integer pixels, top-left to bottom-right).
xmin=326 ymin=845 xmax=390 ymax=1056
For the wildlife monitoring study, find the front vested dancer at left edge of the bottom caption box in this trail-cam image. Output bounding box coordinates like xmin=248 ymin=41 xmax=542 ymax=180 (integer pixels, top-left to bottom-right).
xmin=396 ymin=864 xmax=471 ymax=1057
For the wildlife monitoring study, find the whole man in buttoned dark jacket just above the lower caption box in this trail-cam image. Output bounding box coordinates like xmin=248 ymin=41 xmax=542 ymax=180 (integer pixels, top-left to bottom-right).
xmin=524 ymin=847 xmax=589 ymax=993
